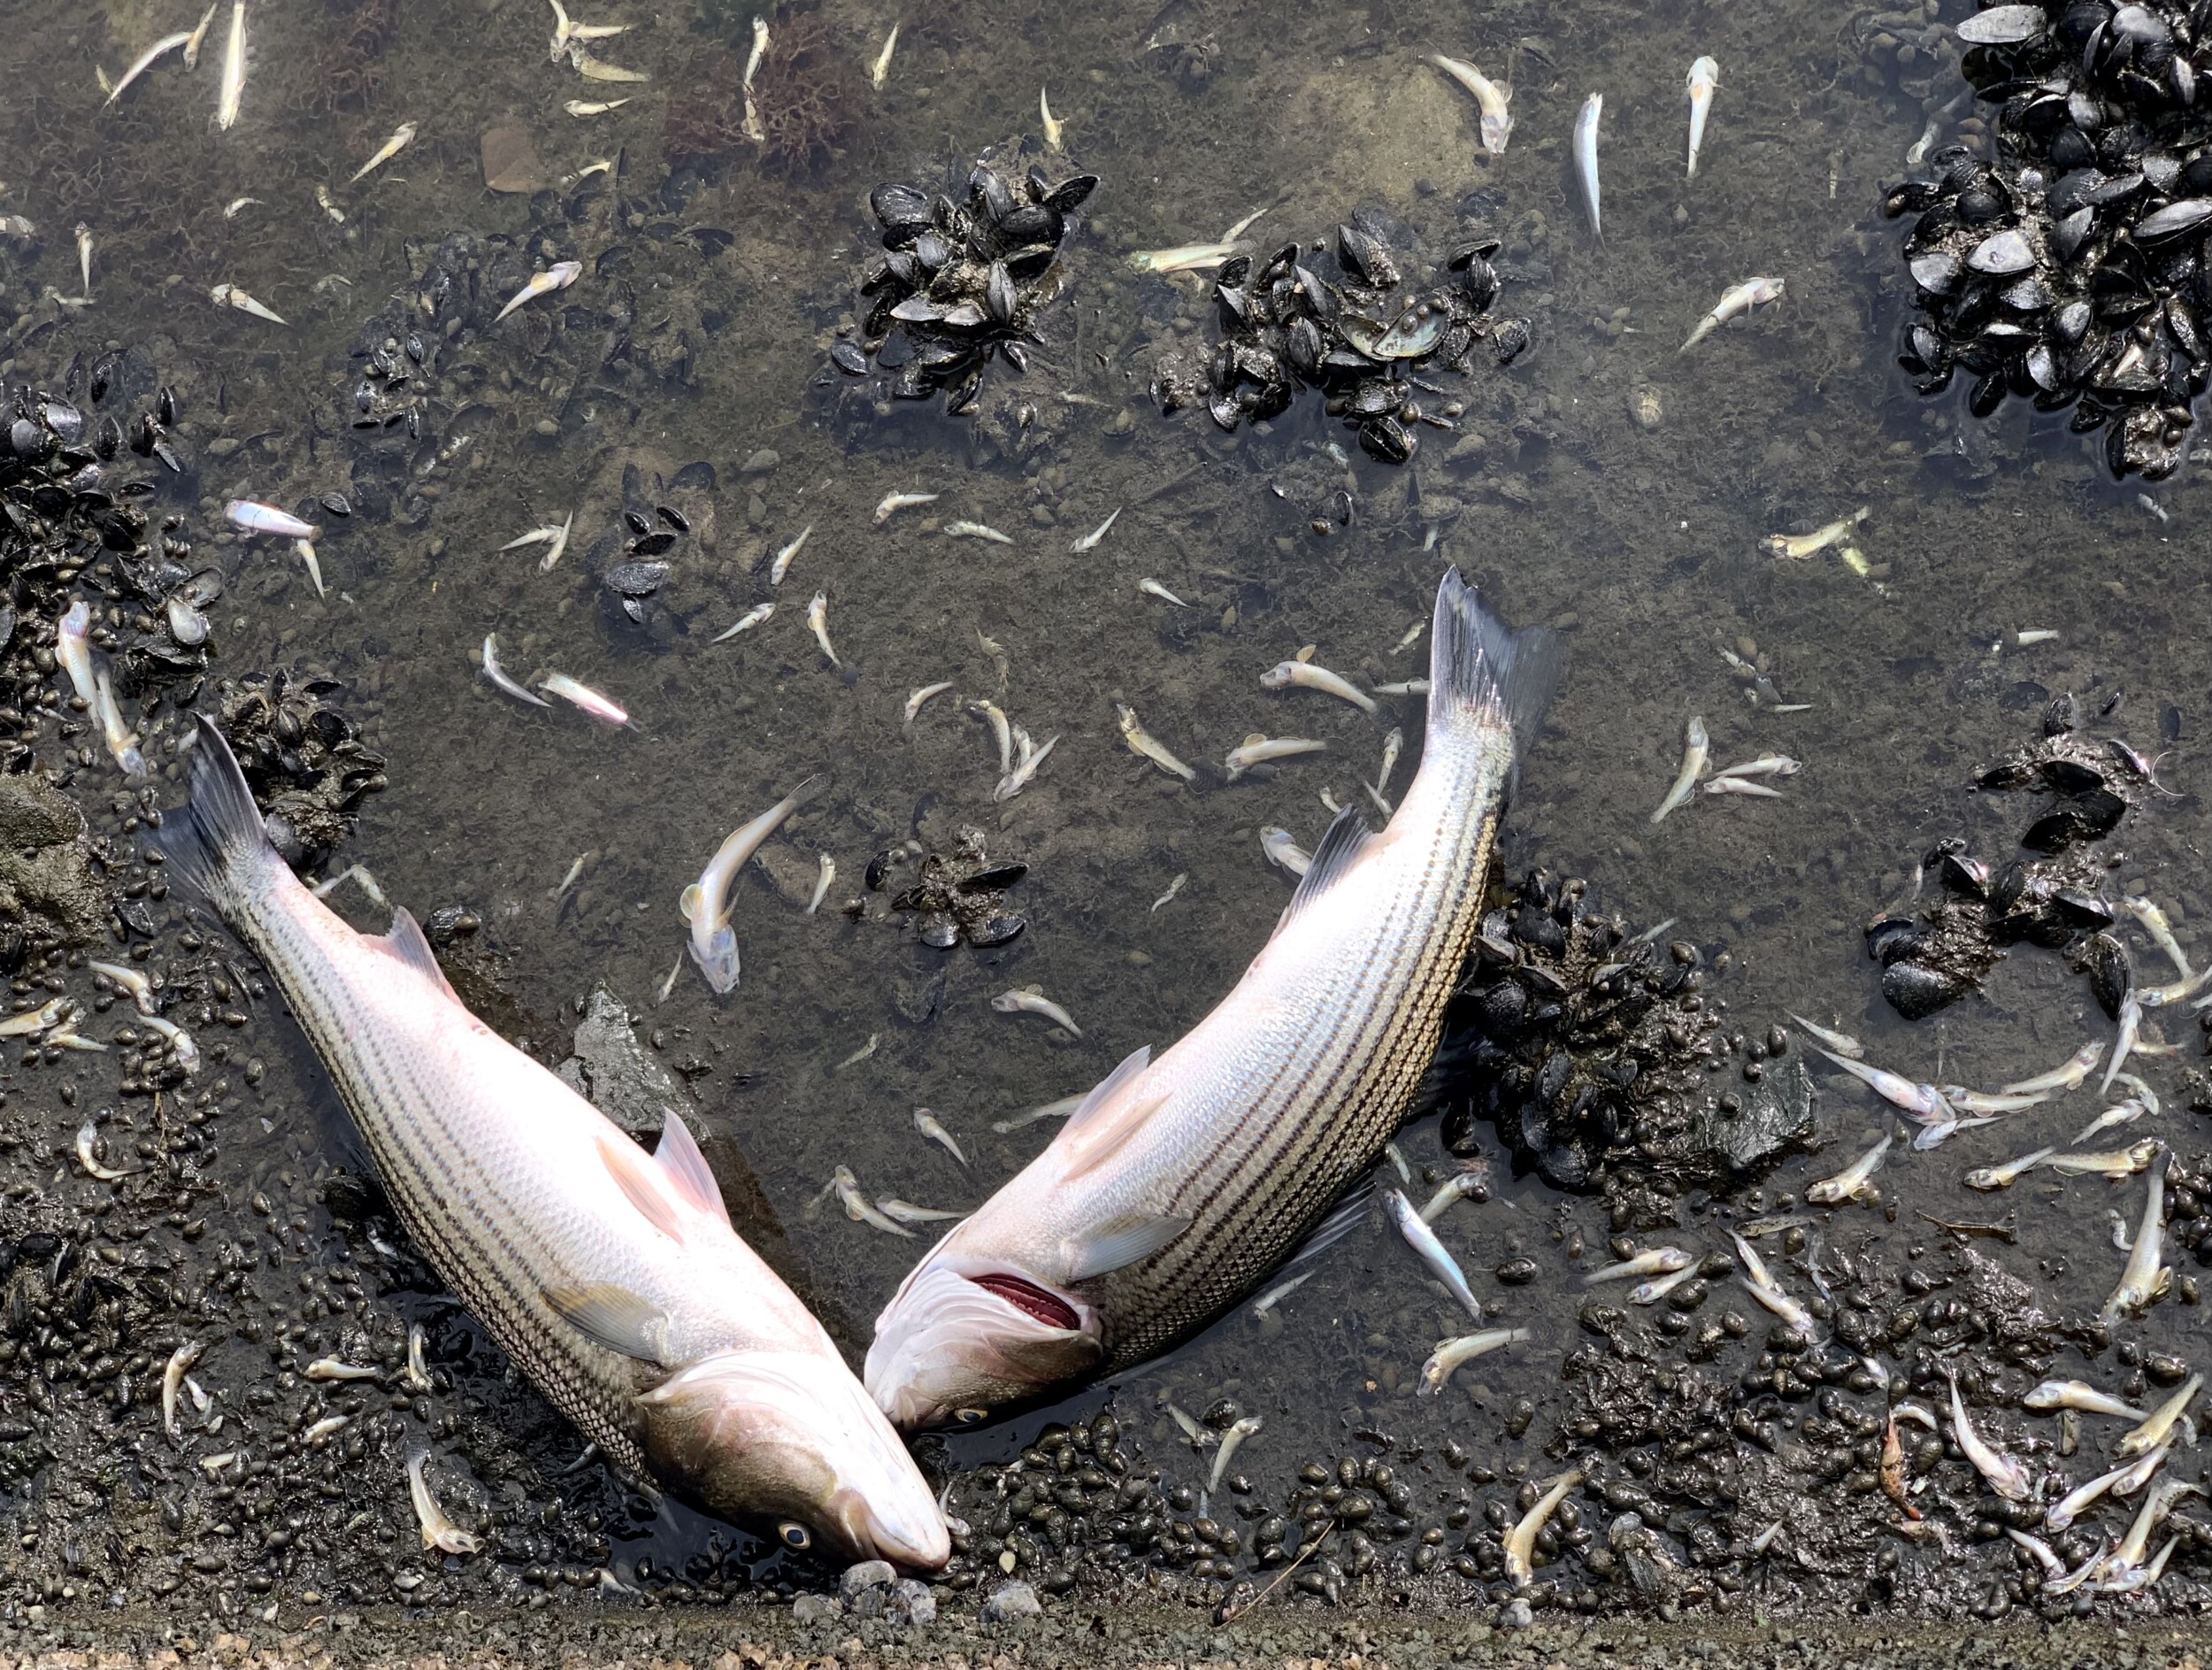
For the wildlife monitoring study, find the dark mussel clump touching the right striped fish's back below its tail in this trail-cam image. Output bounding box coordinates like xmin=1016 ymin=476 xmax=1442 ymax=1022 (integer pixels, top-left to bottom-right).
xmin=1423 ymin=869 xmax=1812 ymax=1192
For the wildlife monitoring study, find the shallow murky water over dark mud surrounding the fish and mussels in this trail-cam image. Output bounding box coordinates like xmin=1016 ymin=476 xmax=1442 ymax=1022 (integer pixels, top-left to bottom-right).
xmin=0 ymin=0 xmax=2212 ymax=1636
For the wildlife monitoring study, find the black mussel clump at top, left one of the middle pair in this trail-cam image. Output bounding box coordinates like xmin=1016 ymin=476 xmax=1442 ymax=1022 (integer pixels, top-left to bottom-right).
xmin=830 ymin=161 xmax=1100 ymax=416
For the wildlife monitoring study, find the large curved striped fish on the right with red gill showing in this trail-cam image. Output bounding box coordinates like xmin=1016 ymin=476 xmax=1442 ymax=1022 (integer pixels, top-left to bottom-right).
xmin=867 ymin=568 xmax=1553 ymax=1427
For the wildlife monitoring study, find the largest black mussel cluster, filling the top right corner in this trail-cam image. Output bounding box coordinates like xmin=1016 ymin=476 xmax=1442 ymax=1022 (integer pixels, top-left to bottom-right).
xmin=1885 ymin=0 xmax=2212 ymax=480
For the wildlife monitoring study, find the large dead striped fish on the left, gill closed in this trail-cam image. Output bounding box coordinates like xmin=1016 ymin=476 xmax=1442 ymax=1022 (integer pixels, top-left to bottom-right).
xmin=162 ymin=719 xmax=949 ymax=1571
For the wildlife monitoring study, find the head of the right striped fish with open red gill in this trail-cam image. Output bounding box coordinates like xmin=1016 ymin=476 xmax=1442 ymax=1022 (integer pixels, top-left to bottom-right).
xmin=865 ymin=1257 xmax=1106 ymax=1431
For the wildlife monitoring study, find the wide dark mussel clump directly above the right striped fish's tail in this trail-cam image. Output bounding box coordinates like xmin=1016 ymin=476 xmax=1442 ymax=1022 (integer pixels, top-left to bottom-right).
xmin=1155 ymin=217 xmax=1529 ymax=465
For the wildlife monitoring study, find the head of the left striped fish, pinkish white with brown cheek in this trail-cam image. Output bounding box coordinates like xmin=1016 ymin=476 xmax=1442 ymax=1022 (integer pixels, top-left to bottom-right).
xmin=640 ymin=1351 xmax=951 ymax=1571
